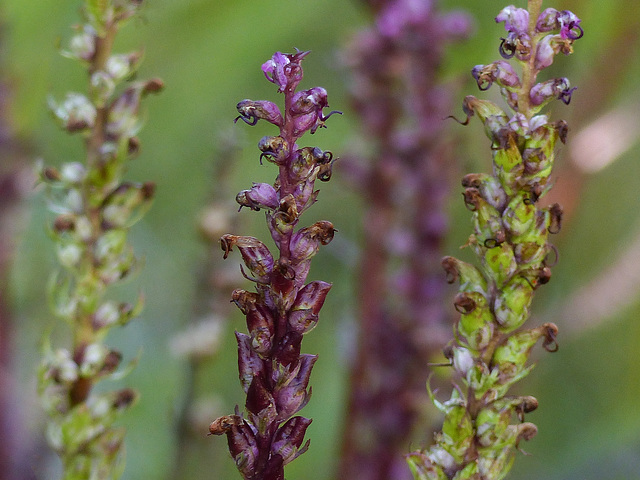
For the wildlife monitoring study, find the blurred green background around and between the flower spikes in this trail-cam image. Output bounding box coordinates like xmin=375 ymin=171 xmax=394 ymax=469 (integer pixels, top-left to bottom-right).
xmin=0 ymin=0 xmax=640 ymax=480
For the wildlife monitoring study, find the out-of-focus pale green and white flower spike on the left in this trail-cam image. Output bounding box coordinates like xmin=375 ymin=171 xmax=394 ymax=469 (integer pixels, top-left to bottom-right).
xmin=39 ymin=0 xmax=162 ymax=480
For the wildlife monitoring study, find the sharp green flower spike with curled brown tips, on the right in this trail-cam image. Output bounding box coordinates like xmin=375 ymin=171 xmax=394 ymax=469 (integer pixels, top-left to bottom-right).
xmin=408 ymin=0 xmax=582 ymax=480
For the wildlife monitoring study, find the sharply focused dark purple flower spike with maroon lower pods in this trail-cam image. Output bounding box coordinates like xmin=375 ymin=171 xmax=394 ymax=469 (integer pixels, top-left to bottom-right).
xmin=209 ymin=51 xmax=339 ymax=480
